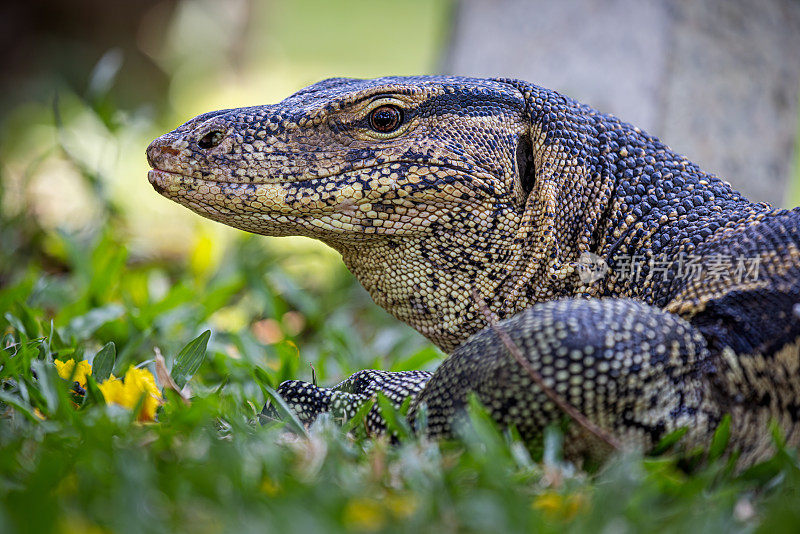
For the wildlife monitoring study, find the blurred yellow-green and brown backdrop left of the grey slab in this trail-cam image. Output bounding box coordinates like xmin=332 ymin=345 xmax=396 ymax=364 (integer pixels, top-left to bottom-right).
xmin=0 ymin=0 xmax=452 ymax=255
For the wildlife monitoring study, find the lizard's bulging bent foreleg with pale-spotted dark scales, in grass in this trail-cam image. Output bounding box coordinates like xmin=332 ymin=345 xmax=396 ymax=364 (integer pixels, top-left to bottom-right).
xmin=410 ymin=299 xmax=718 ymax=454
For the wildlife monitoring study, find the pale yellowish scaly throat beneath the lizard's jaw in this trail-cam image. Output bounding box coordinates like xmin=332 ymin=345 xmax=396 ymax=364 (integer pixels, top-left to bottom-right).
xmin=334 ymin=202 xmax=548 ymax=352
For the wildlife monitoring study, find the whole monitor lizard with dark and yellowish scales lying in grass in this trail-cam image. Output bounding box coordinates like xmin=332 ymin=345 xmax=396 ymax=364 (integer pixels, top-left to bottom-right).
xmin=147 ymin=76 xmax=800 ymax=463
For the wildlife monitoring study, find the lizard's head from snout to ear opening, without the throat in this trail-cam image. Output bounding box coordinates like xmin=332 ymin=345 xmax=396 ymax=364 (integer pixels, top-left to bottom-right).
xmin=147 ymin=78 xmax=536 ymax=240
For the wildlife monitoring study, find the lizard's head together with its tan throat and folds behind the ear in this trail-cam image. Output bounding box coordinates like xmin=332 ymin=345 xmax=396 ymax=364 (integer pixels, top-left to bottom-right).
xmin=147 ymin=76 xmax=608 ymax=350
